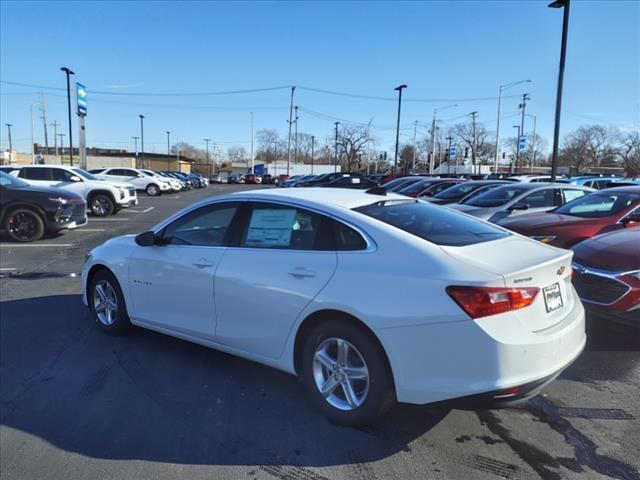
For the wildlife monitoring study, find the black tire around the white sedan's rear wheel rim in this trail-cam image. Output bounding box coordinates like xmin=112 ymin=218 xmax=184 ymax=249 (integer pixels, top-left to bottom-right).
xmin=302 ymin=318 xmax=395 ymax=426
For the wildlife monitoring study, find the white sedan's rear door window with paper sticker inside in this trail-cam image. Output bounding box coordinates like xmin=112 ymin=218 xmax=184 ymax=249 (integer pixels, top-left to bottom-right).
xmin=240 ymin=202 xmax=335 ymax=250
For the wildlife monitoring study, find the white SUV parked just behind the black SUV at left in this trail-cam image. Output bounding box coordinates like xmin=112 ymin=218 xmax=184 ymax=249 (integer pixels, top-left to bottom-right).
xmin=11 ymin=165 xmax=138 ymax=217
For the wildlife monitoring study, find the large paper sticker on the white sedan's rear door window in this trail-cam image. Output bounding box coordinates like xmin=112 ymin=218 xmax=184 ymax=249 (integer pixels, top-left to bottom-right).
xmin=246 ymin=208 xmax=296 ymax=247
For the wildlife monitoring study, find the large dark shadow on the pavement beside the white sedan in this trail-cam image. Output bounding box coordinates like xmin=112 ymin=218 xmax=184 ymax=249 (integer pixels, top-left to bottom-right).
xmin=0 ymin=295 xmax=449 ymax=467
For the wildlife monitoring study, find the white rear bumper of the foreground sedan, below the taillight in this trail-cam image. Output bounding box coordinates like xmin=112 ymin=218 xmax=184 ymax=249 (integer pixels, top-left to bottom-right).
xmin=376 ymin=301 xmax=586 ymax=404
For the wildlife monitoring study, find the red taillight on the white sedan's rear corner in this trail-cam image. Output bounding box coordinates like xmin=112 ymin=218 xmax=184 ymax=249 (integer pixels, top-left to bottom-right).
xmin=447 ymin=286 xmax=540 ymax=318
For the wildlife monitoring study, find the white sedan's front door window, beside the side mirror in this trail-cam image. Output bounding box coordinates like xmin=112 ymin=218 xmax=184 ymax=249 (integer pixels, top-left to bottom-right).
xmin=162 ymin=203 xmax=238 ymax=247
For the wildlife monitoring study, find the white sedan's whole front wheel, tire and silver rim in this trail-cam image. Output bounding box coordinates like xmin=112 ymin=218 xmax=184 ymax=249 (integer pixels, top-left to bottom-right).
xmin=89 ymin=270 xmax=131 ymax=335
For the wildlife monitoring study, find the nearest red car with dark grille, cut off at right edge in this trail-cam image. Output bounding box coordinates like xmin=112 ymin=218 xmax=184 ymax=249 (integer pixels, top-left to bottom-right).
xmin=573 ymin=227 xmax=640 ymax=328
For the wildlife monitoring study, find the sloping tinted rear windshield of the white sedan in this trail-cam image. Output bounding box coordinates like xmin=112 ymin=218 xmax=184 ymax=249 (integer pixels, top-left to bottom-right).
xmin=354 ymin=202 xmax=509 ymax=247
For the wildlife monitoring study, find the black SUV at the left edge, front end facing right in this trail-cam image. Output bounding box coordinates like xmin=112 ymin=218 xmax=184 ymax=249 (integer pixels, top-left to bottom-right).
xmin=0 ymin=172 xmax=87 ymax=242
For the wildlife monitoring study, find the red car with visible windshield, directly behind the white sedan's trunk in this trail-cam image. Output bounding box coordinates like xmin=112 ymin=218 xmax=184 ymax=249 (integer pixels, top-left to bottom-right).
xmin=498 ymin=186 xmax=640 ymax=249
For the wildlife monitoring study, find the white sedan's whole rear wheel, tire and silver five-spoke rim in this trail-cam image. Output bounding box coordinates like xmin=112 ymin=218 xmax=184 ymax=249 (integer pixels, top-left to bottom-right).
xmin=302 ymin=320 xmax=394 ymax=426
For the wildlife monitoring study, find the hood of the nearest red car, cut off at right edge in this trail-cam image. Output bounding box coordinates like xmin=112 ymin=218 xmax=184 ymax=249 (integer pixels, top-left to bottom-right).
xmin=572 ymin=227 xmax=640 ymax=271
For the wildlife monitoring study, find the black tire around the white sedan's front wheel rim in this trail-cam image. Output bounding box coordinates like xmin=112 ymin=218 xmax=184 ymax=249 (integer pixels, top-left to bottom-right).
xmin=87 ymin=269 xmax=131 ymax=335
